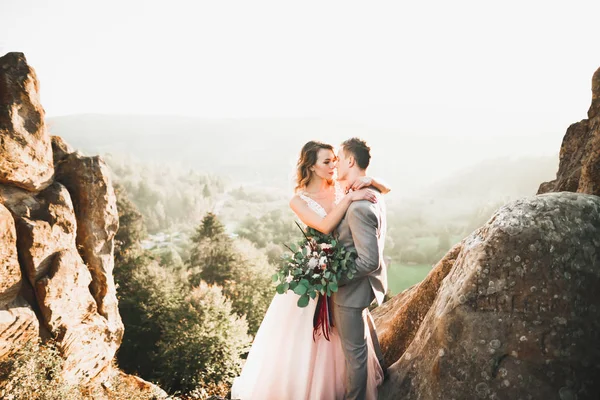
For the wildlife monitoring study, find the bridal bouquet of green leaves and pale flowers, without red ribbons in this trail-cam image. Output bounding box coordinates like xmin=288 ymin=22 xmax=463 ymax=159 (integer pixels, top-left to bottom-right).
xmin=273 ymin=223 xmax=356 ymax=307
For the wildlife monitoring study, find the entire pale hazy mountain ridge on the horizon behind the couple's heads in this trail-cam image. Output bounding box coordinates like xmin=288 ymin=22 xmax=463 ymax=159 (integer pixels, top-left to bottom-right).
xmin=48 ymin=114 xmax=558 ymax=199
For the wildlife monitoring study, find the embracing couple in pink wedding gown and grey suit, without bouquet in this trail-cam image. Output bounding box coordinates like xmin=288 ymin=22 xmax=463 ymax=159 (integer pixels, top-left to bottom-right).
xmin=231 ymin=138 xmax=389 ymax=400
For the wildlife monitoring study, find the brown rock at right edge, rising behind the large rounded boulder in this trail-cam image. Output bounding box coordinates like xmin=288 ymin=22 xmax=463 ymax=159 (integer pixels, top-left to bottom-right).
xmin=538 ymin=68 xmax=600 ymax=196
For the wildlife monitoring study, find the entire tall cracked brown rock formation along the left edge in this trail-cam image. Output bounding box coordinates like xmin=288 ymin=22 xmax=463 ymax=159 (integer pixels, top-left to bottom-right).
xmin=0 ymin=54 xmax=123 ymax=384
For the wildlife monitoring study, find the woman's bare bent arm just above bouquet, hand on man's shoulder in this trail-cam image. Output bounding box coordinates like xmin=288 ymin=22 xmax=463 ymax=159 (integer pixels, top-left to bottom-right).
xmin=290 ymin=189 xmax=377 ymax=235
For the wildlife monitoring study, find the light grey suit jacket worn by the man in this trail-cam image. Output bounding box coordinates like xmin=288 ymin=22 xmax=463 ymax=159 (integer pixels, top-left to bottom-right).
xmin=332 ymin=193 xmax=387 ymax=308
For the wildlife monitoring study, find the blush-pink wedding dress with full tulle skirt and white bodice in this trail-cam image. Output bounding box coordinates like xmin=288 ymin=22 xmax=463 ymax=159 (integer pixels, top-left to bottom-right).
xmin=231 ymin=184 xmax=383 ymax=400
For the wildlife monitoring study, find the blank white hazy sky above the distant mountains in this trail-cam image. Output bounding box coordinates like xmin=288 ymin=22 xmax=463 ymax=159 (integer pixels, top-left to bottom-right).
xmin=0 ymin=0 xmax=600 ymax=152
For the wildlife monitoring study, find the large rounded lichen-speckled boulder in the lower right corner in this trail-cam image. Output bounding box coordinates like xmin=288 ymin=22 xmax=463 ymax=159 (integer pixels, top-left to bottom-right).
xmin=380 ymin=193 xmax=600 ymax=400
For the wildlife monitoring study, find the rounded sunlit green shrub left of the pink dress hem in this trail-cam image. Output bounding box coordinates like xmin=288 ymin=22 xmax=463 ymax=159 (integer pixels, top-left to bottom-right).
xmin=154 ymin=282 xmax=250 ymax=393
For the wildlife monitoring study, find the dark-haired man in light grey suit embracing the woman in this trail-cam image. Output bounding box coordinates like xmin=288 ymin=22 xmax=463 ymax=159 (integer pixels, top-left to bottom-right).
xmin=332 ymin=138 xmax=387 ymax=399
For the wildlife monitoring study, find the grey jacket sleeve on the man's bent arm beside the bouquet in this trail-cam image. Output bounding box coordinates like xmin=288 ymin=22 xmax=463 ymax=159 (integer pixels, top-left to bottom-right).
xmin=338 ymin=202 xmax=381 ymax=286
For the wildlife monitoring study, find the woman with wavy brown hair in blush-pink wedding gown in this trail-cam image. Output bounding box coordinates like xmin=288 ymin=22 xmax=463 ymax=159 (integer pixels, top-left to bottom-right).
xmin=231 ymin=141 xmax=389 ymax=400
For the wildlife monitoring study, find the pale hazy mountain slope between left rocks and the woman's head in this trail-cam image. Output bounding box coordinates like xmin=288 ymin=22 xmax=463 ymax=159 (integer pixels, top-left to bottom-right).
xmin=48 ymin=115 xmax=312 ymax=187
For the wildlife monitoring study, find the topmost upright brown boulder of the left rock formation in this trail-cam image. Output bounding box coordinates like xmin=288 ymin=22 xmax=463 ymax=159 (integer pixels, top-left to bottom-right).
xmin=0 ymin=53 xmax=54 ymax=190
